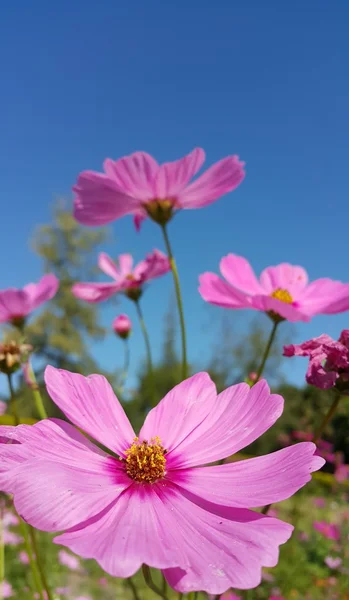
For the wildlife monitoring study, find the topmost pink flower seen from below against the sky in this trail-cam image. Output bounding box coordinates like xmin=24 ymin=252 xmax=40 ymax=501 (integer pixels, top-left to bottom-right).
xmin=73 ymin=148 xmax=245 ymax=228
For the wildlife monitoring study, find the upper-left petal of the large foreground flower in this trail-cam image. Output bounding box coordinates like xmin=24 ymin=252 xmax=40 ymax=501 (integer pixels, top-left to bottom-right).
xmin=45 ymin=366 xmax=135 ymax=455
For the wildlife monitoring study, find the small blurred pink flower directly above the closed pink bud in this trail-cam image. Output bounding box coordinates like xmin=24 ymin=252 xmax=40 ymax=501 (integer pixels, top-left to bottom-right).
xmin=72 ymin=250 xmax=171 ymax=302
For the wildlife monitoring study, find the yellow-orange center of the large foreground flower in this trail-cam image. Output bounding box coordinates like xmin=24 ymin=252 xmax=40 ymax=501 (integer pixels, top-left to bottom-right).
xmin=125 ymin=437 xmax=166 ymax=483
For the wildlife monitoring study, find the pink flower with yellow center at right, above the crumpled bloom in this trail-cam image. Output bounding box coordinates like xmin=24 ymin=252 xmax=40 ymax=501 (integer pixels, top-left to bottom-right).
xmin=199 ymin=254 xmax=349 ymax=321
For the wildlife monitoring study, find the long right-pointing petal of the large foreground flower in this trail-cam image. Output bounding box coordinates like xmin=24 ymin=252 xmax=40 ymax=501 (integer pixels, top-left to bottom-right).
xmin=167 ymin=442 xmax=325 ymax=508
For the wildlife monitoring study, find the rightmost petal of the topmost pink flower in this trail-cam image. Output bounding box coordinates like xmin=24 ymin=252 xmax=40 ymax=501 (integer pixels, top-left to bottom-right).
xmin=178 ymin=156 xmax=245 ymax=208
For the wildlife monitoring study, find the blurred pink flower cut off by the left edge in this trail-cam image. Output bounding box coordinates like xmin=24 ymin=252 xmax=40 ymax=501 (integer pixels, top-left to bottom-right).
xmin=0 ymin=274 xmax=59 ymax=325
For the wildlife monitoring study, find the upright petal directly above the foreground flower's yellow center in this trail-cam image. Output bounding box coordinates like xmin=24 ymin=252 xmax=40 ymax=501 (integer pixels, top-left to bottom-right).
xmin=139 ymin=373 xmax=217 ymax=451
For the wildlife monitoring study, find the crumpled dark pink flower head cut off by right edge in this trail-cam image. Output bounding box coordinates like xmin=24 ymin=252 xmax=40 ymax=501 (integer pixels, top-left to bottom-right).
xmin=284 ymin=329 xmax=349 ymax=394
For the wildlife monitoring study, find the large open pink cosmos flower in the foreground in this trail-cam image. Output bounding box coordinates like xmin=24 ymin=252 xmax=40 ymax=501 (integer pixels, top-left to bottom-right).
xmin=0 ymin=367 xmax=324 ymax=594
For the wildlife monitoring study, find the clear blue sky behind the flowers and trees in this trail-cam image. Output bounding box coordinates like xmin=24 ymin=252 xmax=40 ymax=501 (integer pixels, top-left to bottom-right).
xmin=0 ymin=0 xmax=349 ymax=390
